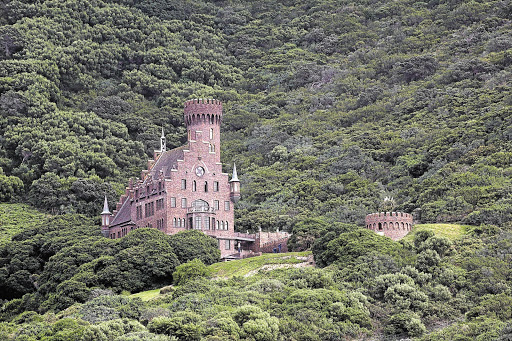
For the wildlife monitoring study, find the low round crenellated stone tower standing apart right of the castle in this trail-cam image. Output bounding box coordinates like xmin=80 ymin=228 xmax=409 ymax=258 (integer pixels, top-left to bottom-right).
xmin=365 ymin=212 xmax=412 ymax=240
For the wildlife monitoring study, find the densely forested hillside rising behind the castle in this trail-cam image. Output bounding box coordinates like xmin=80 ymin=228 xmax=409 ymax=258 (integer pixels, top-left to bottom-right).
xmin=0 ymin=1 xmax=512 ymax=230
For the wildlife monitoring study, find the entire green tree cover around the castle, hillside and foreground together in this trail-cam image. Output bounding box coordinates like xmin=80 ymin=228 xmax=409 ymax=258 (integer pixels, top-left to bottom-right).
xmin=0 ymin=0 xmax=512 ymax=341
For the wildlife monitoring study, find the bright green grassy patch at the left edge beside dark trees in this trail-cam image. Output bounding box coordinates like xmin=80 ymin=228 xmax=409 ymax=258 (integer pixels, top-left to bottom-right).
xmin=0 ymin=204 xmax=45 ymax=246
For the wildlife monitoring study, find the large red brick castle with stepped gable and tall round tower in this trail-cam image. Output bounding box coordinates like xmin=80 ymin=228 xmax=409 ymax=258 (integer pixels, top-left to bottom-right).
xmin=101 ymin=99 xmax=288 ymax=259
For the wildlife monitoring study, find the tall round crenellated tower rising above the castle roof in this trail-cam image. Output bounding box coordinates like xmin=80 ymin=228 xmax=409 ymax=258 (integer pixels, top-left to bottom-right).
xmin=185 ymin=98 xmax=222 ymax=163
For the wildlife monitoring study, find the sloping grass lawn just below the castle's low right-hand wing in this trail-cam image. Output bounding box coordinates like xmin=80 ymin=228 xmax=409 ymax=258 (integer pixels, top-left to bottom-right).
xmin=209 ymin=251 xmax=311 ymax=277
